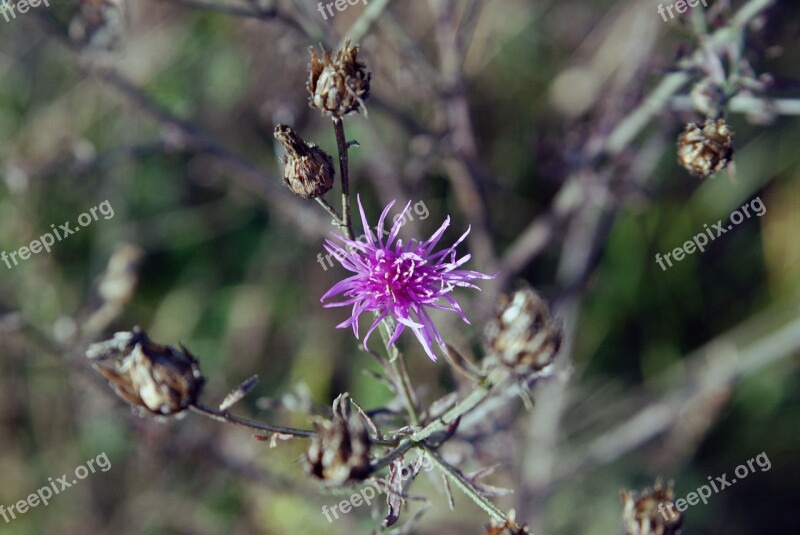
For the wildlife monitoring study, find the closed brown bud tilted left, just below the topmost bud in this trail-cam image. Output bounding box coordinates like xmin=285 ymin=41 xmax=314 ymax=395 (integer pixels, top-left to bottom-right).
xmin=275 ymin=124 xmax=336 ymax=199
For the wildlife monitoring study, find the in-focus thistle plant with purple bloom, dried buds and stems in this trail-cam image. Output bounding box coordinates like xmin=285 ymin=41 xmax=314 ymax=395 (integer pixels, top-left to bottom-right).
xmin=87 ymin=39 xmax=562 ymax=534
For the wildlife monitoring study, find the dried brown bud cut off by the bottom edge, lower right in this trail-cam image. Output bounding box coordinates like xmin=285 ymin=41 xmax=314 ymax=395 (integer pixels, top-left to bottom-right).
xmin=620 ymin=480 xmax=683 ymax=535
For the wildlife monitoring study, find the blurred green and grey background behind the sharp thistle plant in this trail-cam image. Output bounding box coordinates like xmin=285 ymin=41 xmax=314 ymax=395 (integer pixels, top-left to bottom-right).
xmin=0 ymin=0 xmax=800 ymax=534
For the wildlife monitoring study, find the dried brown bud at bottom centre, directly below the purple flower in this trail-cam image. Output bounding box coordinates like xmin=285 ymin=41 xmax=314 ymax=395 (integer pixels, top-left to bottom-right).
xmin=306 ymin=394 xmax=370 ymax=484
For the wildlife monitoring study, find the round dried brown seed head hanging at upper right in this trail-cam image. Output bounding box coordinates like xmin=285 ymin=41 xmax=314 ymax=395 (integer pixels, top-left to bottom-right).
xmin=678 ymin=119 xmax=733 ymax=178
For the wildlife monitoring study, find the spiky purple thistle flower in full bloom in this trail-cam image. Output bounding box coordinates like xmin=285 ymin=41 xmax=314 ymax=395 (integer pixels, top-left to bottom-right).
xmin=320 ymin=197 xmax=494 ymax=361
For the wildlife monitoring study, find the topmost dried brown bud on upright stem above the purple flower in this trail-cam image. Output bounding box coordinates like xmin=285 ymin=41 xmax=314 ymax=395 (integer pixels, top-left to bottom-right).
xmin=306 ymin=41 xmax=372 ymax=117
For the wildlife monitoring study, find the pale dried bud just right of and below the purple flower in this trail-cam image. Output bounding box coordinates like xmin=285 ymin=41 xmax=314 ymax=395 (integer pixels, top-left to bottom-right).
xmin=484 ymin=287 xmax=563 ymax=377
